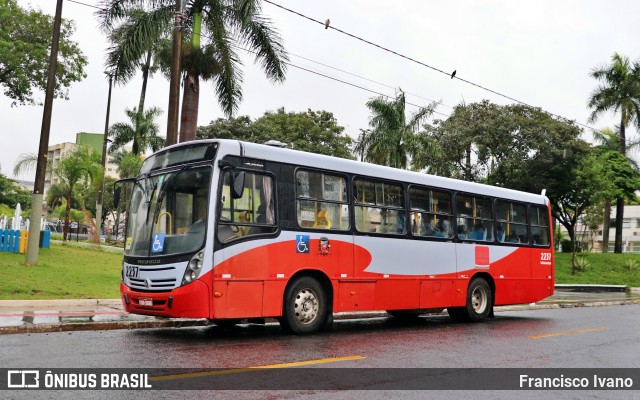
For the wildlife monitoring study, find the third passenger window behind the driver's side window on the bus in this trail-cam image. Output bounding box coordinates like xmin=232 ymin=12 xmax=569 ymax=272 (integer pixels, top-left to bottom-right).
xmin=409 ymin=187 xmax=453 ymax=238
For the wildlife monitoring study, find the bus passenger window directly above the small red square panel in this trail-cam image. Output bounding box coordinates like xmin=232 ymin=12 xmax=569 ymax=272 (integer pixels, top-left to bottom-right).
xmin=456 ymin=195 xmax=493 ymax=242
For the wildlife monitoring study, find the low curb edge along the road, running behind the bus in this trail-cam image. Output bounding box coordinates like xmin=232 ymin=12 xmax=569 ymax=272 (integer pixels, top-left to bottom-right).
xmin=0 ymin=299 xmax=640 ymax=335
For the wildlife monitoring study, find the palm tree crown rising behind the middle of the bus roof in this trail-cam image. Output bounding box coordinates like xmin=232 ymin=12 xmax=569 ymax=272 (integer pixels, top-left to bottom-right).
xmin=354 ymin=89 xmax=436 ymax=169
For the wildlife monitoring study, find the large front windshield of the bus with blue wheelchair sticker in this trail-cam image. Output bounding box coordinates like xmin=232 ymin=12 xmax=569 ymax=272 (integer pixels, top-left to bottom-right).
xmin=125 ymin=165 xmax=211 ymax=257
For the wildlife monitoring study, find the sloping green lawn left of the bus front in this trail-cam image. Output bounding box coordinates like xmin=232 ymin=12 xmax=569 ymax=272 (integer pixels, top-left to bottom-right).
xmin=0 ymin=243 xmax=122 ymax=300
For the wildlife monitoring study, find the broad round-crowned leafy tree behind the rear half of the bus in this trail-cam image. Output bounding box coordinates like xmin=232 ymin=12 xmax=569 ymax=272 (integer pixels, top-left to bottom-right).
xmin=420 ymin=100 xmax=586 ymax=186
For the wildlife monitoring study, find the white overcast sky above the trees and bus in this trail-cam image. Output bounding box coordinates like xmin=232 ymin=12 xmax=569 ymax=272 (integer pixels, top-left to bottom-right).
xmin=0 ymin=0 xmax=640 ymax=181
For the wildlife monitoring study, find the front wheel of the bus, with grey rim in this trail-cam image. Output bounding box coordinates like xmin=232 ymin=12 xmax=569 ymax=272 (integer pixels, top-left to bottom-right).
xmin=280 ymin=276 xmax=327 ymax=335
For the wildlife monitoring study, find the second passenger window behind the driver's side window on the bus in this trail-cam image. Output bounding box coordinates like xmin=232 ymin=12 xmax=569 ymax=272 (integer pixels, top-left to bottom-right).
xmin=353 ymin=179 xmax=407 ymax=235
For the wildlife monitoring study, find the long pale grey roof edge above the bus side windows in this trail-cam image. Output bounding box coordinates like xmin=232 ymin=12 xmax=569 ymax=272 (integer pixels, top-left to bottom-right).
xmin=168 ymin=139 xmax=548 ymax=205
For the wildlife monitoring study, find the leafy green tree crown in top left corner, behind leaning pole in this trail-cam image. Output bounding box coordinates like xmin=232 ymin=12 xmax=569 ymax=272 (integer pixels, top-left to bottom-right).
xmin=0 ymin=0 xmax=87 ymax=106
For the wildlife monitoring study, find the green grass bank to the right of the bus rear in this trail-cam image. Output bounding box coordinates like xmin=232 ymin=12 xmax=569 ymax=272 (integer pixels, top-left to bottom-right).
xmin=556 ymin=253 xmax=640 ymax=287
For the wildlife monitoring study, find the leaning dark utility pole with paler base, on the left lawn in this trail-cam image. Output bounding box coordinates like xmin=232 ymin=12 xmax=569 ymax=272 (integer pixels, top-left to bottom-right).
xmin=25 ymin=0 xmax=62 ymax=265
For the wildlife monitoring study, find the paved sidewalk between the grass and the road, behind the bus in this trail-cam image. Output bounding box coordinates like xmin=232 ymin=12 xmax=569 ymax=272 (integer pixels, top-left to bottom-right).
xmin=0 ymin=285 xmax=640 ymax=334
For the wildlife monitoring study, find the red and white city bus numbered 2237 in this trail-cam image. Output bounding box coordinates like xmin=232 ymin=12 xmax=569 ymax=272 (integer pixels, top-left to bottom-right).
xmin=116 ymin=140 xmax=554 ymax=334
